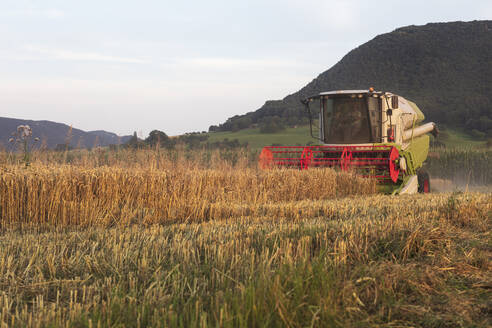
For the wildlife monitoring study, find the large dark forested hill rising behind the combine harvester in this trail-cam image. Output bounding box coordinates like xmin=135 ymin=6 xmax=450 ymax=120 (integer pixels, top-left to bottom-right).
xmin=210 ymin=21 xmax=492 ymax=138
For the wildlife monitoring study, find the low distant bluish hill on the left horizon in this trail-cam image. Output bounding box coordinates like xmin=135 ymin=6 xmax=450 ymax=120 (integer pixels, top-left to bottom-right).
xmin=0 ymin=117 xmax=131 ymax=148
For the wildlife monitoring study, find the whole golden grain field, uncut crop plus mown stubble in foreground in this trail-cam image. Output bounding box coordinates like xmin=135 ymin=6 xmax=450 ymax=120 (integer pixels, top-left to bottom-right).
xmin=0 ymin=152 xmax=492 ymax=327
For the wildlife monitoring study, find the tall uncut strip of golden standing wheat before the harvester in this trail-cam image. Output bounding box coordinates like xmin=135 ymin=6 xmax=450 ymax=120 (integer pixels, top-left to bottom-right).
xmin=0 ymin=165 xmax=375 ymax=227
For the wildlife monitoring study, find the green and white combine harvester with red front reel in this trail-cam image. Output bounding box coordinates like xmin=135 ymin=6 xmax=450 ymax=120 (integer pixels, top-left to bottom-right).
xmin=259 ymin=88 xmax=438 ymax=194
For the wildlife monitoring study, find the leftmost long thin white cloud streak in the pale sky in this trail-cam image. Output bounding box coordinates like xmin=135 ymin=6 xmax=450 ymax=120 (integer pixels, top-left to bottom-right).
xmin=25 ymin=45 xmax=146 ymax=64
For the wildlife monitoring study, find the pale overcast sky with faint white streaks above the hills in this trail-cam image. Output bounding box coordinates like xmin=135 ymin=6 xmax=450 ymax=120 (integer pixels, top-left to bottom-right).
xmin=0 ymin=0 xmax=492 ymax=137
